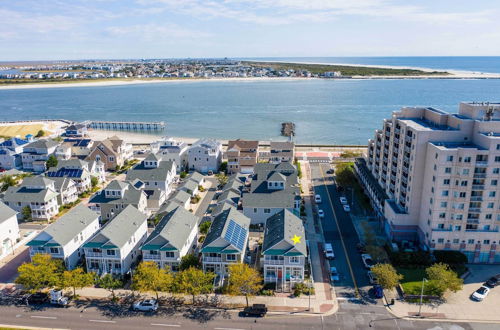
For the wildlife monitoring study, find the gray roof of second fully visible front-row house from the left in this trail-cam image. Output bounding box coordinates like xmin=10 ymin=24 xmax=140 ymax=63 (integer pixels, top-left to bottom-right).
xmin=87 ymin=205 xmax=148 ymax=248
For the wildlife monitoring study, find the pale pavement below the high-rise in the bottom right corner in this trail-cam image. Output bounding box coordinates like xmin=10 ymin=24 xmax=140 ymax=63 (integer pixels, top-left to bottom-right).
xmin=386 ymin=265 xmax=500 ymax=323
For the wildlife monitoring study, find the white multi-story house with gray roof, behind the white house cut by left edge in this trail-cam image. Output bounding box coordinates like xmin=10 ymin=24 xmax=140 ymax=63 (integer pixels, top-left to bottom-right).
xmin=4 ymin=176 xmax=59 ymax=220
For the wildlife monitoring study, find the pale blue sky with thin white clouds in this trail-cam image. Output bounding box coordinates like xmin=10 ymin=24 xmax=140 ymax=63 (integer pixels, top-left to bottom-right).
xmin=0 ymin=0 xmax=500 ymax=61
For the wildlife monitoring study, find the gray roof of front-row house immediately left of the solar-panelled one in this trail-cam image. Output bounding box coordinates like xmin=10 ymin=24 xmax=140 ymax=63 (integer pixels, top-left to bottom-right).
xmin=143 ymin=206 xmax=200 ymax=251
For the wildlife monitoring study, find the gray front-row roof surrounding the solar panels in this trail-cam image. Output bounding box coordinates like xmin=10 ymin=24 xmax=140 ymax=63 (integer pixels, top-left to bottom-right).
xmin=202 ymin=206 xmax=250 ymax=252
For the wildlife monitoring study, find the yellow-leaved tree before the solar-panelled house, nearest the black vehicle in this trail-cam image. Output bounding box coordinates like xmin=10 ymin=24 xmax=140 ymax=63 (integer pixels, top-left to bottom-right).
xmin=228 ymin=263 xmax=262 ymax=307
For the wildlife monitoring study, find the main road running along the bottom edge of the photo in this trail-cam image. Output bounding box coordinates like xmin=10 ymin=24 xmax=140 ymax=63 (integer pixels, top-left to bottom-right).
xmin=0 ymin=302 xmax=488 ymax=330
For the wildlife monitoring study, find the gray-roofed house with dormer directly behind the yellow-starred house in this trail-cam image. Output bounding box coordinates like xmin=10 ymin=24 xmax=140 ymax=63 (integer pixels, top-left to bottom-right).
xmin=242 ymin=162 xmax=301 ymax=224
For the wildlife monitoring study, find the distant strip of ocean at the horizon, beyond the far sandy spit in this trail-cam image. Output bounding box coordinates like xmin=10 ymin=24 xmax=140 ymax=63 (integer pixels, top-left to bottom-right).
xmin=243 ymin=56 xmax=500 ymax=73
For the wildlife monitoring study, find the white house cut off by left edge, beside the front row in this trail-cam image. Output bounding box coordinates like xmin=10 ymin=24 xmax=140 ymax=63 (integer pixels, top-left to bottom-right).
xmin=0 ymin=201 xmax=19 ymax=260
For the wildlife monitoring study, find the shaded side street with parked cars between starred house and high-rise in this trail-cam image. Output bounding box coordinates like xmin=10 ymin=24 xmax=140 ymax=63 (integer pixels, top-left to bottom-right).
xmin=311 ymin=163 xmax=377 ymax=304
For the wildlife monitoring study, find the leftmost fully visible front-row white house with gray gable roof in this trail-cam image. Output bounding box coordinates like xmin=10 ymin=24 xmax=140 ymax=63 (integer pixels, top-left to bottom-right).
xmin=27 ymin=204 xmax=99 ymax=270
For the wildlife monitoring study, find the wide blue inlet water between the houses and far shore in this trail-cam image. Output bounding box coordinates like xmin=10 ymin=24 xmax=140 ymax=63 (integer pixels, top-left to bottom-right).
xmin=0 ymin=79 xmax=500 ymax=144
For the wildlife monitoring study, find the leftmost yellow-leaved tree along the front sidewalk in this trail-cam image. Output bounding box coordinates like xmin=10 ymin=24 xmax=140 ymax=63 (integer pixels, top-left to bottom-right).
xmin=16 ymin=254 xmax=63 ymax=292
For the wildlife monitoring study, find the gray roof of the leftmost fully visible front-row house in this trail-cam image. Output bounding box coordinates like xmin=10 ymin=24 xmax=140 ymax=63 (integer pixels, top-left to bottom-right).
xmin=33 ymin=204 xmax=99 ymax=246
